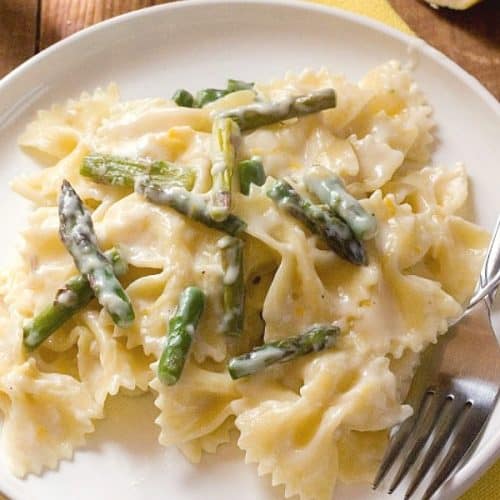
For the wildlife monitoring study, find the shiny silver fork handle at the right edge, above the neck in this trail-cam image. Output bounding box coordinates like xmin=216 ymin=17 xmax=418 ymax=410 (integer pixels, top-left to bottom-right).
xmin=467 ymin=217 xmax=500 ymax=309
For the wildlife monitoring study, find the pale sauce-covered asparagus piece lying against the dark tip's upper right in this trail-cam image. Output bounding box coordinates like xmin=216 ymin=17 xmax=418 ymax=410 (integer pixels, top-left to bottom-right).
xmin=304 ymin=169 xmax=377 ymax=240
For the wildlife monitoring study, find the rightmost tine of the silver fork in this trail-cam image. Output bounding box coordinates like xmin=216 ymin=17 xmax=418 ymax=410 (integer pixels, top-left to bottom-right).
xmin=423 ymin=403 xmax=488 ymax=500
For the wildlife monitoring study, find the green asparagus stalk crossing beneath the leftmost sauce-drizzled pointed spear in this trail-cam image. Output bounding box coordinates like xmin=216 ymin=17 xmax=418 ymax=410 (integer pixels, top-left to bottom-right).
xmin=23 ymin=248 xmax=127 ymax=350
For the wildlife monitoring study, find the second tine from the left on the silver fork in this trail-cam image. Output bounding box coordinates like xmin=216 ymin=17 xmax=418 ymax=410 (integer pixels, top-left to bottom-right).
xmin=389 ymin=393 xmax=450 ymax=494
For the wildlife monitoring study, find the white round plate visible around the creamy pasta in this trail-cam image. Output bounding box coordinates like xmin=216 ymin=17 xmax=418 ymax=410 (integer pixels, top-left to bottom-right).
xmin=0 ymin=0 xmax=500 ymax=500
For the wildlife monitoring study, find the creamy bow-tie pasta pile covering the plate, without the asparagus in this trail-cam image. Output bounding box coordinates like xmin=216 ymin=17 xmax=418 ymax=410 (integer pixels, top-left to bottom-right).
xmin=0 ymin=61 xmax=488 ymax=500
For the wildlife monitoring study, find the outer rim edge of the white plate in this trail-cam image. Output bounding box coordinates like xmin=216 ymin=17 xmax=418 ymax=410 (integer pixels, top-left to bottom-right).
xmin=0 ymin=0 xmax=500 ymax=497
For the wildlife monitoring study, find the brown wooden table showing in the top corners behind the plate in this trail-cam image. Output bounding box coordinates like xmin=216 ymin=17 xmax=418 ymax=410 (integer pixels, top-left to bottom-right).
xmin=0 ymin=0 xmax=500 ymax=99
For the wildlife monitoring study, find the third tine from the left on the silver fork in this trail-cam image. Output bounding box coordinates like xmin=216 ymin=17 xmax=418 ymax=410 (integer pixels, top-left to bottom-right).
xmin=405 ymin=396 xmax=463 ymax=500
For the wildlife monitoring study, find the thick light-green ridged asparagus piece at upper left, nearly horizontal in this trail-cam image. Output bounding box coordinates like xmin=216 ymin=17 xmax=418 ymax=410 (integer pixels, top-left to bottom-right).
xmin=80 ymin=153 xmax=195 ymax=189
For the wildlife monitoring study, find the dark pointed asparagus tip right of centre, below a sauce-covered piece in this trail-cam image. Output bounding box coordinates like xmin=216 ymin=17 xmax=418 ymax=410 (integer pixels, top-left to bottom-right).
xmin=267 ymin=181 xmax=367 ymax=265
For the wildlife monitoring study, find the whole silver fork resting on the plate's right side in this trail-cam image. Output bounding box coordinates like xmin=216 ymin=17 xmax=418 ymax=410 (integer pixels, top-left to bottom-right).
xmin=373 ymin=218 xmax=500 ymax=500
